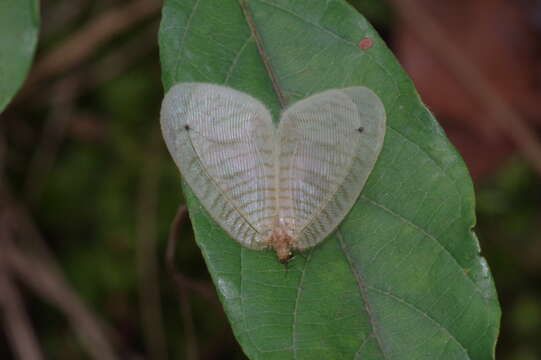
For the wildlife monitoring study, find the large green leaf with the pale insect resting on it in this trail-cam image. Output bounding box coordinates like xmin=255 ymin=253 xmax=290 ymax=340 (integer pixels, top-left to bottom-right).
xmin=160 ymin=0 xmax=500 ymax=360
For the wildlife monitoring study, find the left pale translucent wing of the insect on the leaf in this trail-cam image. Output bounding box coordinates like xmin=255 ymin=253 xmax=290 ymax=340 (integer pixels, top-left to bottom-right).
xmin=161 ymin=83 xmax=276 ymax=249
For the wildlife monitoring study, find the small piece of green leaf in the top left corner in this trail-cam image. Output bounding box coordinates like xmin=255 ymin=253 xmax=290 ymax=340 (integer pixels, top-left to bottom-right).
xmin=0 ymin=0 xmax=39 ymax=112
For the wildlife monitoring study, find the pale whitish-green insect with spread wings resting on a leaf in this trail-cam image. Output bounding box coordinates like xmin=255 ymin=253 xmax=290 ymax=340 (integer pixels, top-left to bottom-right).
xmin=161 ymin=83 xmax=386 ymax=263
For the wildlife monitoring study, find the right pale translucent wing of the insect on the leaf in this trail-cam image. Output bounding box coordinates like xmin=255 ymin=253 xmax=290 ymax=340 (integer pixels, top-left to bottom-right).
xmin=278 ymin=87 xmax=385 ymax=250
